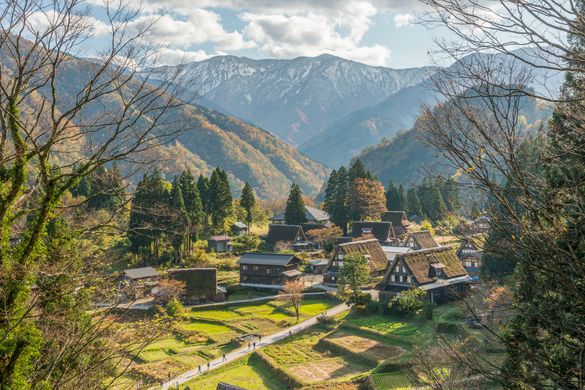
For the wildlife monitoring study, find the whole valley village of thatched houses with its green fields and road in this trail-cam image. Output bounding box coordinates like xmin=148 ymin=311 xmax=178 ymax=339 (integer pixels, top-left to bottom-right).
xmin=108 ymin=181 xmax=492 ymax=389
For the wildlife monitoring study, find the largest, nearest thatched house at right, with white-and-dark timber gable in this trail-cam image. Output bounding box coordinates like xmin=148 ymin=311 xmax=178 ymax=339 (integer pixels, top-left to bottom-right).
xmin=379 ymin=246 xmax=471 ymax=303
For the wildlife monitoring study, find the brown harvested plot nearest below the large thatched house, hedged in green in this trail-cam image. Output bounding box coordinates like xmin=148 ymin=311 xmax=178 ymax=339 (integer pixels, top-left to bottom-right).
xmin=327 ymin=332 xmax=406 ymax=362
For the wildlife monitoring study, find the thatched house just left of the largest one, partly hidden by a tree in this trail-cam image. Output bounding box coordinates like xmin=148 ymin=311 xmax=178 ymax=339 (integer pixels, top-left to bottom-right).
xmin=323 ymin=238 xmax=388 ymax=285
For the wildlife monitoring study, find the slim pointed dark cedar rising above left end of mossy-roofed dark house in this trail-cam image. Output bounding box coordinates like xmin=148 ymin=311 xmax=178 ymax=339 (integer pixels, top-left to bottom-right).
xmin=168 ymin=176 xmax=189 ymax=262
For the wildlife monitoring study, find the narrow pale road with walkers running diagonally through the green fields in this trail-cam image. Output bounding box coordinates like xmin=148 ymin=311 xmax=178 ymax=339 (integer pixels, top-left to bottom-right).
xmin=162 ymin=303 xmax=349 ymax=390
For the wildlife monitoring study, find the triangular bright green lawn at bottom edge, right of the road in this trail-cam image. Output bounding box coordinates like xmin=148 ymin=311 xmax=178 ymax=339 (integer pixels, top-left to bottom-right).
xmin=180 ymin=357 xmax=287 ymax=390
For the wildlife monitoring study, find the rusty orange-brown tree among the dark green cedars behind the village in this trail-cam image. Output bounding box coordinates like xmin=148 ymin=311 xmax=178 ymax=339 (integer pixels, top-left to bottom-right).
xmin=348 ymin=178 xmax=386 ymax=221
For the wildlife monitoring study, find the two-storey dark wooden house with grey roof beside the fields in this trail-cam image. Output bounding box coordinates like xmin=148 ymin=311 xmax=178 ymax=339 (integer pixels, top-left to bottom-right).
xmin=238 ymin=252 xmax=302 ymax=288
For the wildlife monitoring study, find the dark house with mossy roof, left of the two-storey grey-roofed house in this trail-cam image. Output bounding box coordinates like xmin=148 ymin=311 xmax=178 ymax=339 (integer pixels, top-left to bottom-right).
xmin=168 ymin=268 xmax=226 ymax=305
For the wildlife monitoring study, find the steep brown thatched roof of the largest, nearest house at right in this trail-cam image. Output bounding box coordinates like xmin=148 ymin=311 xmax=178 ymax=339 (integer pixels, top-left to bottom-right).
xmin=384 ymin=246 xmax=467 ymax=285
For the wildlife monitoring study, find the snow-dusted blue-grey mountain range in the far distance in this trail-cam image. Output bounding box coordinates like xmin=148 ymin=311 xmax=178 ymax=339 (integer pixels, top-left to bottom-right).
xmin=149 ymin=55 xmax=434 ymax=145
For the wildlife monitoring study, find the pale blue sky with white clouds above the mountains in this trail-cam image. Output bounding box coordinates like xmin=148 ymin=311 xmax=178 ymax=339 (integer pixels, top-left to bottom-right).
xmin=75 ymin=0 xmax=448 ymax=68
